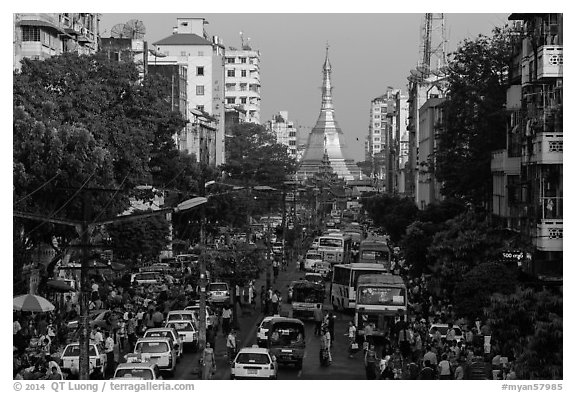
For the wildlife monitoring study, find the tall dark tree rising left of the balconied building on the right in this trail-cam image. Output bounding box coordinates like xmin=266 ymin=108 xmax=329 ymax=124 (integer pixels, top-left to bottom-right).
xmin=429 ymin=28 xmax=512 ymax=208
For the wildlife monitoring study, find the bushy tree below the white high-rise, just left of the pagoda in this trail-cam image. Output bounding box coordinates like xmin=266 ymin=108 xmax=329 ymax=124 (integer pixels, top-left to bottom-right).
xmin=222 ymin=123 xmax=296 ymax=187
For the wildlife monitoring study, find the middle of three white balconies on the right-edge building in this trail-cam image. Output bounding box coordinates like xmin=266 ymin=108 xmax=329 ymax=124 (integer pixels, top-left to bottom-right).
xmin=522 ymin=132 xmax=564 ymax=165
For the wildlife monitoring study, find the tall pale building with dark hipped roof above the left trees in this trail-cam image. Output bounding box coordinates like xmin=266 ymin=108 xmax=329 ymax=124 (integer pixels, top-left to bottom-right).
xmin=148 ymin=18 xmax=225 ymax=166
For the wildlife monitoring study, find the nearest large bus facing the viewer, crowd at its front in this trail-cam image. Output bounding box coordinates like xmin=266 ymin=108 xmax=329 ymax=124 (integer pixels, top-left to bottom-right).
xmin=354 ymin=274 xmax=408 ymax=344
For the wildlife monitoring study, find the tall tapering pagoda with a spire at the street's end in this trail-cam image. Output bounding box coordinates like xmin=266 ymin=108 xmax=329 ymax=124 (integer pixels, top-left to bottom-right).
xmin=297 ymin=46 xmax=361 ymax=180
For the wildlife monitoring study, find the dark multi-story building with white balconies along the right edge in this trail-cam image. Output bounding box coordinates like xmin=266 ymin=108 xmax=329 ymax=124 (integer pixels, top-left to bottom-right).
xmin=491 ymin=14 xmax=564 ymax=278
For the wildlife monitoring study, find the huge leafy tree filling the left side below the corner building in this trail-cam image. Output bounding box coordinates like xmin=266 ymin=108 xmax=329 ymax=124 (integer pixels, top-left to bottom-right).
xmin=13 ymin=54 xmax=185 ymax=258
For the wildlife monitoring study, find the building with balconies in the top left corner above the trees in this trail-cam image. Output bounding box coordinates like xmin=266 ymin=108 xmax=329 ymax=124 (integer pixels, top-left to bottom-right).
xmin=13 ymin=13 xmax=100 ymax=70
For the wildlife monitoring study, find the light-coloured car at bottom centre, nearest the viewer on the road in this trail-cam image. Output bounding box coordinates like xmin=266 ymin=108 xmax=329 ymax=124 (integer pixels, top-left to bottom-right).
xmin=230 ymin=345 xmax=278 ymax=379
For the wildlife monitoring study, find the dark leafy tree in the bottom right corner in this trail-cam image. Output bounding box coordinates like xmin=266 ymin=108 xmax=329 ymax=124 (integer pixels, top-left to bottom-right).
xmin=485 ymin=288 xmax=563 ymax=380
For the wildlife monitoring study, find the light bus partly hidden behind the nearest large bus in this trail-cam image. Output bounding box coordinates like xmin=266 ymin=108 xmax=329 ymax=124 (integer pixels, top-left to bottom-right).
xmin=330 ymin=263 xmax=388 ymax=310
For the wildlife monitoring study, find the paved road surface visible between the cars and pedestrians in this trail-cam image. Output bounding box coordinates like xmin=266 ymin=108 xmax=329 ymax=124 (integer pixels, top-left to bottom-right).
xmin=170 ymin=254 xmax=365 ymax=380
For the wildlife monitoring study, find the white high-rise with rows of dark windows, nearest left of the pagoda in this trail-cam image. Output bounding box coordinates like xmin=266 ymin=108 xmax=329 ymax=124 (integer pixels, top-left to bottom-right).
xmin=224 ymin=44 xmax=261 ymax=124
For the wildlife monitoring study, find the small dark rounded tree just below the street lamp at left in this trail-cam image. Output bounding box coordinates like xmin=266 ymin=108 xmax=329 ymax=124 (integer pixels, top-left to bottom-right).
xmin=106 ymin=211 xmax=170 ymax=261
